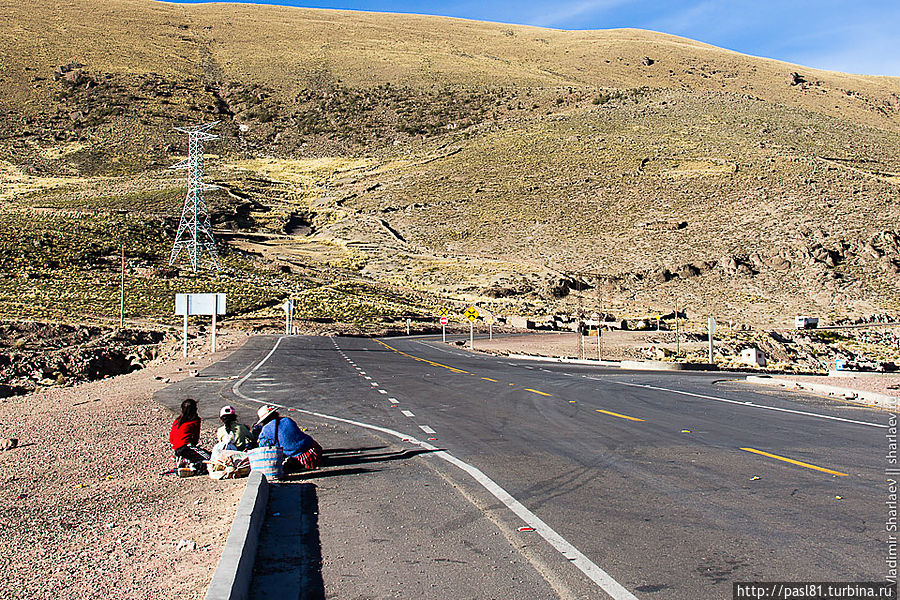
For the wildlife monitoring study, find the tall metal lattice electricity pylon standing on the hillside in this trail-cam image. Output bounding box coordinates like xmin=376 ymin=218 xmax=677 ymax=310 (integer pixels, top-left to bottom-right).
xmin=169 ymin=121 xmax=219 ymax=272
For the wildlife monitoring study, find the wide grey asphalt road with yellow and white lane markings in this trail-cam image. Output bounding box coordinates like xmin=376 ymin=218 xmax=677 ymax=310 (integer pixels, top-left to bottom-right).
xmin=160 ymin=336 xmax=888 ymax=600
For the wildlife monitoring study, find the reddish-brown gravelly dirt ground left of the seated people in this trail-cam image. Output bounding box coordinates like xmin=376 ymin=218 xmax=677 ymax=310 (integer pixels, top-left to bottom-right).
xmin=0 ymin=332 xmax=253 ymax=600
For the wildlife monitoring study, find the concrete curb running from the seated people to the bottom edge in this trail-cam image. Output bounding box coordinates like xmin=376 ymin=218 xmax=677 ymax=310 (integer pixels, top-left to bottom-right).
xmin=205 ymin=471 xmax=269 ymax=600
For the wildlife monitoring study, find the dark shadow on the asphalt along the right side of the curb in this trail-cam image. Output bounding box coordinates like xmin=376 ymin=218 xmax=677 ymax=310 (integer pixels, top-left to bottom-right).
xmin=249 ymin=481 xmax=325 ymax=600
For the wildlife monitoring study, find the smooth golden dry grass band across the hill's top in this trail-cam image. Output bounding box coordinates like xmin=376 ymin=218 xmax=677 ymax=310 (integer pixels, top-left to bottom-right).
xmin=0 ymin=0 xmax=900 ymax=127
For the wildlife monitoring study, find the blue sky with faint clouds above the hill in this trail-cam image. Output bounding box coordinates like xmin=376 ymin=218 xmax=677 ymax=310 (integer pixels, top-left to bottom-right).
xmin=167 ymin=0 xmax=900 ymax=76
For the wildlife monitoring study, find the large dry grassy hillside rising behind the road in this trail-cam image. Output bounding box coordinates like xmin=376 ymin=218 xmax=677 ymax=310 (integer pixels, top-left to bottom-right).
xmin=0 ymin=0 xmax=900 ymax=328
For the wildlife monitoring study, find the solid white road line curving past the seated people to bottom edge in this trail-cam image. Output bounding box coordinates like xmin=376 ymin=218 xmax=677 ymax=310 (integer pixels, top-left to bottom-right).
xmin=231 ymin=336 xmax=638 ymax=600
